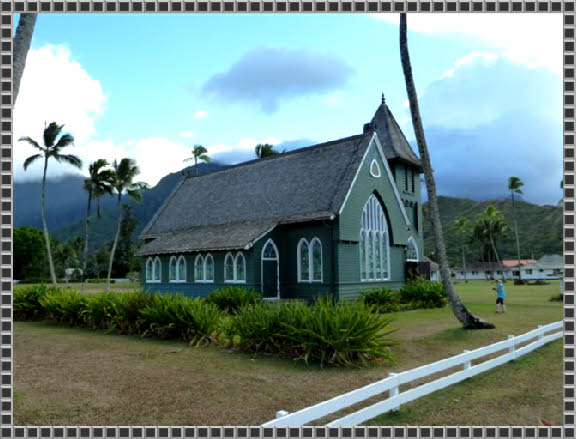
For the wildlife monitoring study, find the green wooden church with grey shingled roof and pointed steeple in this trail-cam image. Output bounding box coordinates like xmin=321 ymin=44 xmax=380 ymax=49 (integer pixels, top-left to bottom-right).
xmin=138 ymin=99 xmax=424 ymax=299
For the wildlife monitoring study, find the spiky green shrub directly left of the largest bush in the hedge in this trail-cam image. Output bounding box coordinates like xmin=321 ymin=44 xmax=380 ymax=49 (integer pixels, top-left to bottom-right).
xmin=140 ymin=294 xmax=223 ymax=346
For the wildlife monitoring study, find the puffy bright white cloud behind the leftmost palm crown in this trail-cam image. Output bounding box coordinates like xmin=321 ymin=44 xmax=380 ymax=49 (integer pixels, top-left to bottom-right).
xmin=14 ymin=45 xmax=106 ymax=180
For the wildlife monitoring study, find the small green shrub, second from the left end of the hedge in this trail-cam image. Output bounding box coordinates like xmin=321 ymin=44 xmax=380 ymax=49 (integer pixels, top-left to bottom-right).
xmin=39 ymin=289 xmax=87 ymax=326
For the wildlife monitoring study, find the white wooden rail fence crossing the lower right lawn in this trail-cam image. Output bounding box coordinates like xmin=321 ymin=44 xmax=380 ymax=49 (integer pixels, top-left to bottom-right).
xmin=263 ymin=321 xmax=562 ymax=427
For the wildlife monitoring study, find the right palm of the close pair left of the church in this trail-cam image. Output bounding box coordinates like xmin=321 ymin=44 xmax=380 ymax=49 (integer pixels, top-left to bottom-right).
xmin=106 ymin=158 xmax=149 ymax=291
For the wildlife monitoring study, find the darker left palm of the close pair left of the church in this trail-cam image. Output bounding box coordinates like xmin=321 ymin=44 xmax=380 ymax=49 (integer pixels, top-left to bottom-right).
xmin=82 ymin=159 xmax=114 ymax=292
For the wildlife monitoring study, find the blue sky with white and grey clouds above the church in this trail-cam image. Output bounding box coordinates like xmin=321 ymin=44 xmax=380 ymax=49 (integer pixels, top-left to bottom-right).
xmin=14 ymin=14 xmax=562 ymax=203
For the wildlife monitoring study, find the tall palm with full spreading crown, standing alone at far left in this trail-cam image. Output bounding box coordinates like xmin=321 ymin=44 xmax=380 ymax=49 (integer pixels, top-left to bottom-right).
xmin=18 ymin=122 xmax=82 ymax=285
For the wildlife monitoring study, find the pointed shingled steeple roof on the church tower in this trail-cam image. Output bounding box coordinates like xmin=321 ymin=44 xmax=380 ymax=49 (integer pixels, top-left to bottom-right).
xmin=370 ymin=102 xmax=422 ymax=169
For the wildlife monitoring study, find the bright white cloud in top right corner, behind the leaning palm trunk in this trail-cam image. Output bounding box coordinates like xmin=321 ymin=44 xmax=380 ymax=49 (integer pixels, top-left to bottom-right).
xmin=373 ymin=13 xmax=562 ymax=74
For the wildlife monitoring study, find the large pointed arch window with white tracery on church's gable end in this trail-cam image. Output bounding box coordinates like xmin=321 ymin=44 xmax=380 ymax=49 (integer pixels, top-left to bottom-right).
xmin=359 ymin=194 xmax=390 ymax=281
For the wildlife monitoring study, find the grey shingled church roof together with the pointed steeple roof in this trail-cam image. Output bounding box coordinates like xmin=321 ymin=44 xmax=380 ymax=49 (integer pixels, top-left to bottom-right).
xmin=138 ymin=104 xmax=419 ymax=255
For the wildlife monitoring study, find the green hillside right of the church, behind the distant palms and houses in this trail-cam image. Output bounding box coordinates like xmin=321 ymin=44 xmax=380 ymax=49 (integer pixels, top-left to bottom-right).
xmin=424 ymin=196 xmax=562 ymax=264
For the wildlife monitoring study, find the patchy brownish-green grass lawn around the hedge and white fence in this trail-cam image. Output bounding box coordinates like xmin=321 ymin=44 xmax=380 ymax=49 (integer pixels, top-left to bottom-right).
xmin=14 ymin=281 xmax=562 ymax=425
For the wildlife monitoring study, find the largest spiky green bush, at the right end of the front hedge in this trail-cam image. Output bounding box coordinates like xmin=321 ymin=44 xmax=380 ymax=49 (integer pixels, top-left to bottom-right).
xmin=225 ymin=299 xmax=393 ymax=367
